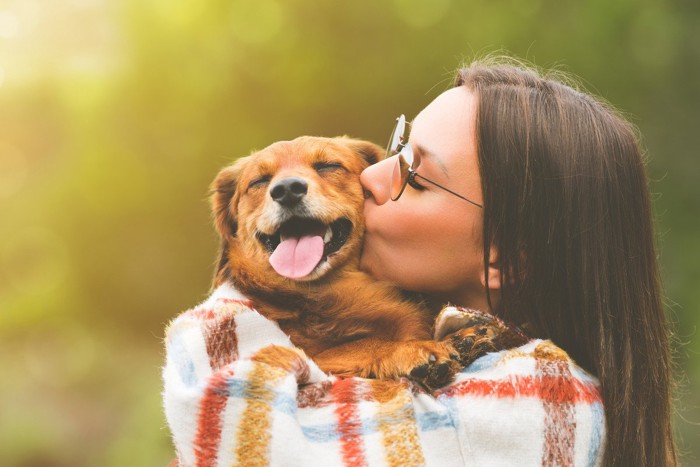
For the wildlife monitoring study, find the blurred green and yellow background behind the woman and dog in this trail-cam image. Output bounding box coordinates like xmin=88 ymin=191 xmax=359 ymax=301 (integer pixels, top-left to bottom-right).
xmin=0 ymin=0 xmax=700 ymax=466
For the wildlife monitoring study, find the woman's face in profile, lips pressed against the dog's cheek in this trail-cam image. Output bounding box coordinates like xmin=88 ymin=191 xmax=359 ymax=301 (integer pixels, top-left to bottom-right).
xmin=360 ymin=86 xmax=485 ymax=307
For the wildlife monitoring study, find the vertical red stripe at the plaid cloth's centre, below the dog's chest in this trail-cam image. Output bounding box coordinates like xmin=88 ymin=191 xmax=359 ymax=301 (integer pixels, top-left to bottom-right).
xmin=331 ymin=378 xmax=367 ymax=466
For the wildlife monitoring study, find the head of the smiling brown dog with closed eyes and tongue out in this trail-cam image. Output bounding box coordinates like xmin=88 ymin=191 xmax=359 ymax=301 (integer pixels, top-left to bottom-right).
xmin=212 ymin=136 xmax=383 ymax=285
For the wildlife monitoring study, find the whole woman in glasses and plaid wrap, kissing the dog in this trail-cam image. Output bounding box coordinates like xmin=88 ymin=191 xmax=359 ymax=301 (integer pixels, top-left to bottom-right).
xmin=164 ymin=57 xmax=675 ymax=466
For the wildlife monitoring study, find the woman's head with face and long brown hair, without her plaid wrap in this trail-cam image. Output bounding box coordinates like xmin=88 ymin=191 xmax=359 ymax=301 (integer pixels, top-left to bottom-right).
xmin=362 ymin=63 xmax=675 ymax=466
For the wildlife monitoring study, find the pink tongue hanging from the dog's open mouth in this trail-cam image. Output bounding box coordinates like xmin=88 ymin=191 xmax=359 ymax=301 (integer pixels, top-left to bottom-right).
xmin=270 ymin=235 xmax=323 ymax=279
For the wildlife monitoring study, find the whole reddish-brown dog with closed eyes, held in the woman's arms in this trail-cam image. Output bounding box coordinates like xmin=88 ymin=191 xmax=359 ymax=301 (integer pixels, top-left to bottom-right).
xmin=212 ymin=137 xmax=456 ymax=387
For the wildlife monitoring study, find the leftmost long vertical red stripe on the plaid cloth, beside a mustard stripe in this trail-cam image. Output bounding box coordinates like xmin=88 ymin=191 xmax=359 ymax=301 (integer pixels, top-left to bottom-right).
xmin=194 ymin=371 xmax=232 ymax=467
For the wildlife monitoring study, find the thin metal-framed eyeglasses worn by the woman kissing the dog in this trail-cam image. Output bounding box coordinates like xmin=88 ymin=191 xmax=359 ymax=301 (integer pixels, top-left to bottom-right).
xmin=386 ymin=115 xmax=483 ymax=208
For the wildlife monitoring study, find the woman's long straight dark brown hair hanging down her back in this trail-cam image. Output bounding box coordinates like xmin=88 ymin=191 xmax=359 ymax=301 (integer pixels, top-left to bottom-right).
xmin=455 ymin=59 xmax=677 ymax=466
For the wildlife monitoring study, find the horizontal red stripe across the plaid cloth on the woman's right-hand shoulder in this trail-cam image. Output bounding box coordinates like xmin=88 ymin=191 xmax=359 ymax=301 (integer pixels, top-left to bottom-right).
xmin=437 ymin=375 xmax=602 ymax=404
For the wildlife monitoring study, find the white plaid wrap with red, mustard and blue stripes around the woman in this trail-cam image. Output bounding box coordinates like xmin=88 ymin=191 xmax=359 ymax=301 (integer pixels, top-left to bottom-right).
xmin=163 ymin=286 xmax=605 ymax=467
